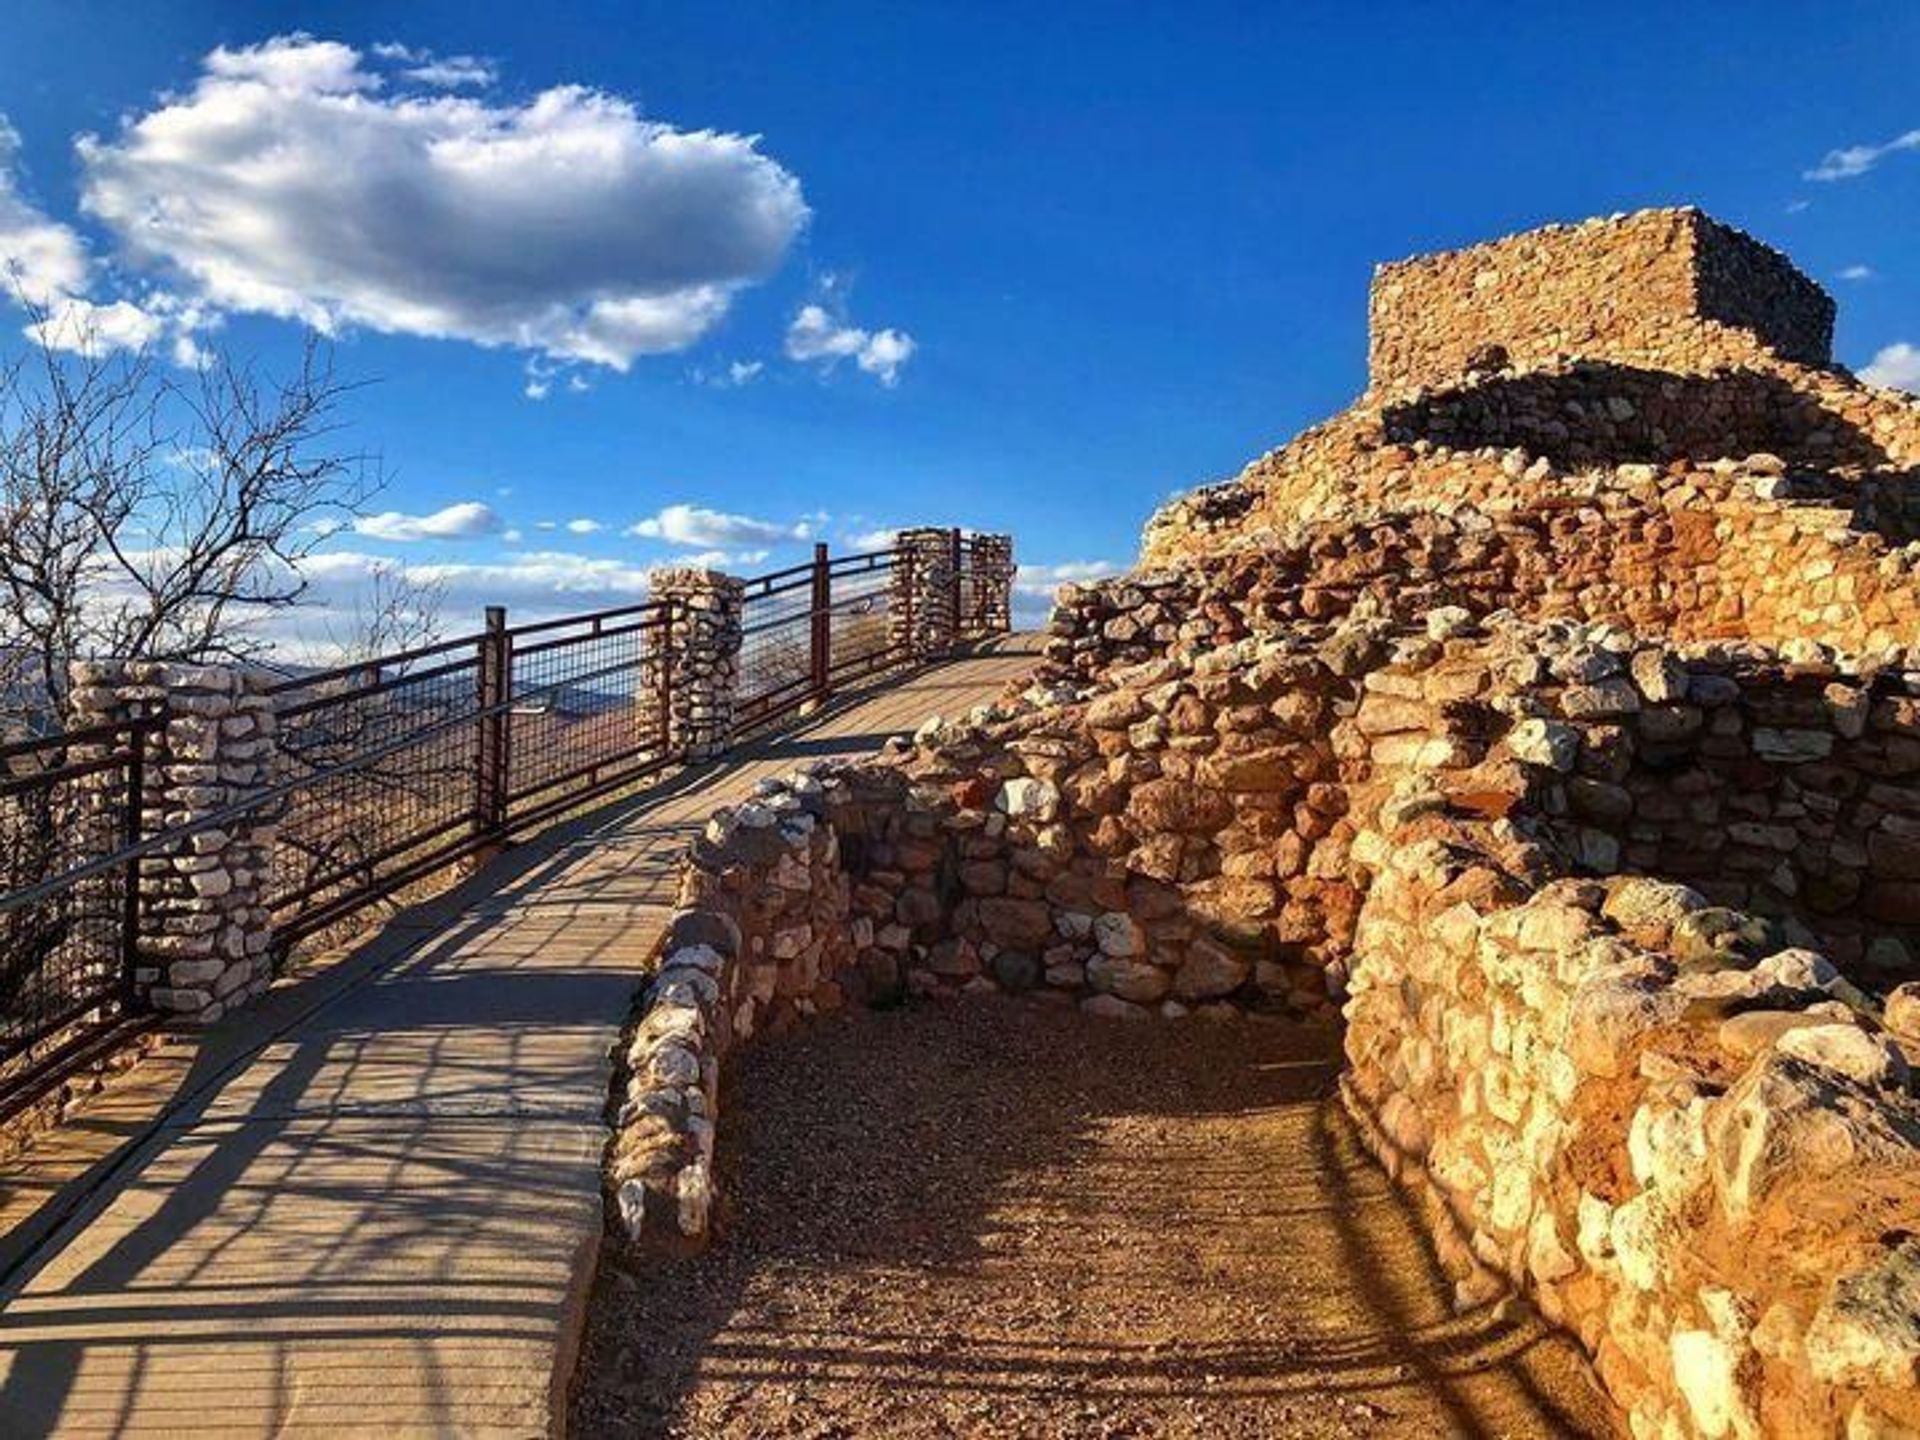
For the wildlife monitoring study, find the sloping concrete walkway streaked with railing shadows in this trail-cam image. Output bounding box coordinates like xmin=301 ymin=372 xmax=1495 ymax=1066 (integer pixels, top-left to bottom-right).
xmin=0 ymin=637 xmax=1033 ymax=1436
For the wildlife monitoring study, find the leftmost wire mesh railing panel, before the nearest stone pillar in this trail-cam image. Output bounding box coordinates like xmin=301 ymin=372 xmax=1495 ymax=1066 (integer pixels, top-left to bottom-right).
xmin=0 ymin=720 xmax=156 ymax=1091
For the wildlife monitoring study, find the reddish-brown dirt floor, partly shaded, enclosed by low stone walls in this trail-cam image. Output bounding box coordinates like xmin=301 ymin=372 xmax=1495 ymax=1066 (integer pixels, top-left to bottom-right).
xmin=572 ymin=1000 xmax=1617 ymax=1440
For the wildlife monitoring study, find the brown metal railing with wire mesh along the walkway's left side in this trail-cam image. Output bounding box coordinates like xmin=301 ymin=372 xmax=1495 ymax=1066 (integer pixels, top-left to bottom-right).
xmin=0 ymin=532 xmax=996 ymax=1117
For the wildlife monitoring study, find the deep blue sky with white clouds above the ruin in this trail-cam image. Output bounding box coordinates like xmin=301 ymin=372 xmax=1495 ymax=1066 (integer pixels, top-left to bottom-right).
xmin=0 ymin=0 xmax=1920 ymax=637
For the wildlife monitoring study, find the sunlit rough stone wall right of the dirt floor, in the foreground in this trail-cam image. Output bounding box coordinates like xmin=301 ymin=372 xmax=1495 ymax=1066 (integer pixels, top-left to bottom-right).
xmin=1344 ymin=831 xmax=1920 ymax=1436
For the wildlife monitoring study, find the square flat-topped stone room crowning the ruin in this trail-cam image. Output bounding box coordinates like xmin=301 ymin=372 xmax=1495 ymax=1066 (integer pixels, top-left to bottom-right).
xmin=1367 ymin=207 xmax=1834 ymax=390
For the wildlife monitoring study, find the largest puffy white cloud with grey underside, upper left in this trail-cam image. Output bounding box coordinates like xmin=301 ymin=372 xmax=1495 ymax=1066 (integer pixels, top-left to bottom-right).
xmin=79 ymin=35 xmax=808 ymax=372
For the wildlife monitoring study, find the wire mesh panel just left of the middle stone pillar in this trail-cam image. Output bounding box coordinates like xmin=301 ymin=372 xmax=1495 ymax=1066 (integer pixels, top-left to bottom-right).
xmin=503 ymin=605 xmax=672 ymax=828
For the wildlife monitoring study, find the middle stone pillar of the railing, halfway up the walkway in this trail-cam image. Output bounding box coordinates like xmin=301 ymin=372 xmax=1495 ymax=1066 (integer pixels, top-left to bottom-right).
xmin=641 ymin=568 xmax=747 ymax=762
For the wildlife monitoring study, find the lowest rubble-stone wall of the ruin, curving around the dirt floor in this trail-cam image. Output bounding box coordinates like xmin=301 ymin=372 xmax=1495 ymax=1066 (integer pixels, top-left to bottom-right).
xmin=612 ymin=612 xmax=1920 ymax=1436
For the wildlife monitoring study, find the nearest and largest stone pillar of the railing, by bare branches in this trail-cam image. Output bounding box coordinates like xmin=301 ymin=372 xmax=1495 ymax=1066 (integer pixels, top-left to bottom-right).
xmin=71 ymin=660 xmax=275 ymax=1023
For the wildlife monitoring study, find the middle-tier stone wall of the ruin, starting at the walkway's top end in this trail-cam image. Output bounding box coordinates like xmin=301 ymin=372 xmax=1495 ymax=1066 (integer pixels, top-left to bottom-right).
xmin=1046 ymin=470 xmax=1920 ymax=680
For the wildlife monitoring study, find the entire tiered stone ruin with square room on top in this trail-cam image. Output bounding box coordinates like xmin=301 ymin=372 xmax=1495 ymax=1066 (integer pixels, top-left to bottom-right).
xmin=611 ymin=209 xmax=1920 ymax=1436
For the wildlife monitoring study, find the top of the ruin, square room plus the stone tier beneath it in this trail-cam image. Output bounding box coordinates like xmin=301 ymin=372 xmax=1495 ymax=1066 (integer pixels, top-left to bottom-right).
xmin=1142 ymin=211 xmax=1920 ymax=579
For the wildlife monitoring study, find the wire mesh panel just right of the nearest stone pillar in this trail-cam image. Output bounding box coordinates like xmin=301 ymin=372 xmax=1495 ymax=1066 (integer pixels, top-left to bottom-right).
xmin=271 ymin=636 xmax=488 ymax=937
